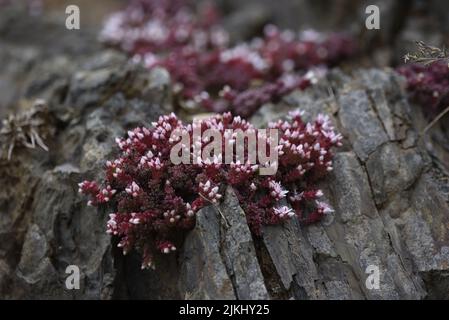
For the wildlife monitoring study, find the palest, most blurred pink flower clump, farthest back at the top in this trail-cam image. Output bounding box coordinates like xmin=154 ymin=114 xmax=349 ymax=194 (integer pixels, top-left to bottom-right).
xmin=100 ymin=0 xmax=224 ymax=55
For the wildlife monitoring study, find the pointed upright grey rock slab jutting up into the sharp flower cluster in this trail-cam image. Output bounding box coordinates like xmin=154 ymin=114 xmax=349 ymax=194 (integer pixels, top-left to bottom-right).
xmin=180 ymin=188 xmax=269 ymax=299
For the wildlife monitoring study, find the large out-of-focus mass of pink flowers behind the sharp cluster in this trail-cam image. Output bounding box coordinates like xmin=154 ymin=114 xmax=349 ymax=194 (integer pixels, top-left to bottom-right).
xmin=101 ymin=0 xmax=355 ymax=117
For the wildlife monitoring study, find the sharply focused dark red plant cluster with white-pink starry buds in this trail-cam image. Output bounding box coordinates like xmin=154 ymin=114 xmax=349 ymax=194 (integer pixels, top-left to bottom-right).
xmin=79 ymin=112 xmax=342 ymax=268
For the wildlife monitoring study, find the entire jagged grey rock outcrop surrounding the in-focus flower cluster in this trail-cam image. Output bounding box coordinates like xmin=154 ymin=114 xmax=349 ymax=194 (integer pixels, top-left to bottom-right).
xmin=0 ymin=1 xmax=449 ymax=299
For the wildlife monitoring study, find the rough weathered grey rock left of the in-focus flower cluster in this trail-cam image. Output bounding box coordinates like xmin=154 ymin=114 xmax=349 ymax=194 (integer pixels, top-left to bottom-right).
xmin=0 ymin=43 xmax=174 ymax=299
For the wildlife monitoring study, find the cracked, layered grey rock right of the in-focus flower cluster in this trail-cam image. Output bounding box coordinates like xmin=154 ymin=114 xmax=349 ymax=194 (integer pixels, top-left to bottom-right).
xmin=247 ymin=70 xmax=449 ymax=299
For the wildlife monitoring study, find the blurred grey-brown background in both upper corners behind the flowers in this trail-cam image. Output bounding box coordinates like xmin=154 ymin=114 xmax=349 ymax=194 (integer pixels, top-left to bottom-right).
xmin=0 ymin=0 xmax=449 ymax=116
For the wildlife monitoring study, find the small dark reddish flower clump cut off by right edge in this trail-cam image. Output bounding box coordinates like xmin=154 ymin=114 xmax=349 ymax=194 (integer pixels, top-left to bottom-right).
xmin=398 ymin=61 xmax=449 ymax=116
